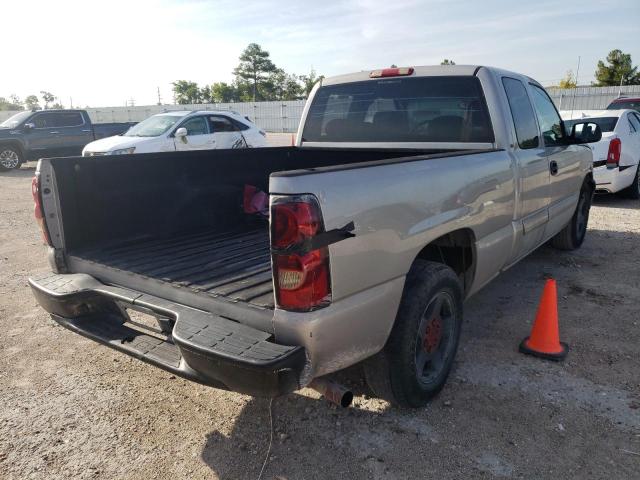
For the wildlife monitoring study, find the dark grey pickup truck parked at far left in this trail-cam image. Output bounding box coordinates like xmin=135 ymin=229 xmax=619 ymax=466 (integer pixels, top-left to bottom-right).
xmin=0 ymin=110 xmax=135 ymax=170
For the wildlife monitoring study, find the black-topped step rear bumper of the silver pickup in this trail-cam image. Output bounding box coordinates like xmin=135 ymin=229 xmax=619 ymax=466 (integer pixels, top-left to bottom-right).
xmin=29 ymin=273 xmax=306 ymax=397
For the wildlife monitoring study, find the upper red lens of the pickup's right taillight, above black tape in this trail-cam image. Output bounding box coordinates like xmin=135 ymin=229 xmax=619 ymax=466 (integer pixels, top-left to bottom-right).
xmin=271 ymin=202 xmax=321 ymax=248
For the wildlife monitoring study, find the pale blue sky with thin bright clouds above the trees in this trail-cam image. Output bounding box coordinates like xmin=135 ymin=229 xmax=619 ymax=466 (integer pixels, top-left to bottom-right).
xmin=0 ymin=0 xmax=640 ymax=107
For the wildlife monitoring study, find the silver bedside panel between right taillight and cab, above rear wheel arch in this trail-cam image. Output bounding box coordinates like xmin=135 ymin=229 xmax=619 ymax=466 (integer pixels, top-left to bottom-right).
xmin=270 ymin=151 xmax=515 ymax=301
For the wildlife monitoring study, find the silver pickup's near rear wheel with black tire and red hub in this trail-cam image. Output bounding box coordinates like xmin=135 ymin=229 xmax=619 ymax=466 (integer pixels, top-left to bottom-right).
xmin=364 ymin=260 xmax=463 ymax=408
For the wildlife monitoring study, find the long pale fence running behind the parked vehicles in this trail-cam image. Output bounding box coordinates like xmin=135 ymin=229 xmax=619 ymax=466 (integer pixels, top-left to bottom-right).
xmin=0 ymin=85 xmax=640 ymax=133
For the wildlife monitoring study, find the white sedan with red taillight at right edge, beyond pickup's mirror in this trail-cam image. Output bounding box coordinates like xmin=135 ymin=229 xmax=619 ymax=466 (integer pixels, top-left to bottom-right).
xmin=565 ymin=109 xmax=640 ymax=199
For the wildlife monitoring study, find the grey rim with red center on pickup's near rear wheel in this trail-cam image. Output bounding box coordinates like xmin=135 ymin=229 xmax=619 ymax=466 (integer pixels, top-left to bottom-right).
xmin=415 ymin=292 xmax=455 ymax=384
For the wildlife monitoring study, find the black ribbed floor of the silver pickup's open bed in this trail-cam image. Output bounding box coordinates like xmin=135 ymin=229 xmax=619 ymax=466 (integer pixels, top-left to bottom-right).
xmin=70 ymin=226 xmax=274 ymax=309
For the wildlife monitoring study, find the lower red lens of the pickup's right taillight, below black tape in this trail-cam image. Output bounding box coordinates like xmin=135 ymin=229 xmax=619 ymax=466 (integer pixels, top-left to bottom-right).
xmin=274 ymin=247 xmax=331 ymax=311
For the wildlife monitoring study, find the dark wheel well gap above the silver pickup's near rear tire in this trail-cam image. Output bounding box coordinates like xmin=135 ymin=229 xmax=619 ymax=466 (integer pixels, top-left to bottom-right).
xmin=416 ymin=228 xmax=476 ymax=293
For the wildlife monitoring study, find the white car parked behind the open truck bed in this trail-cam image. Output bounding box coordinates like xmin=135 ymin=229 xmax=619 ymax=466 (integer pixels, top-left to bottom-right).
xmin=82 ymin=110 xmax=267 ymax=156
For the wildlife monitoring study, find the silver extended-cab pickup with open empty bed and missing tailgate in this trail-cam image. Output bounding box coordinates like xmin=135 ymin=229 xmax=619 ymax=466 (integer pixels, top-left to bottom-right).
xmin=29 ymin=66 xmax=600 ymax=407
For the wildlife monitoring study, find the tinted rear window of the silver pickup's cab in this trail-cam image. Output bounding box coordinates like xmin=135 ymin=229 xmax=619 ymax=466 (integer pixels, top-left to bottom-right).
xmin=302 ymin=77 xmax=493 ymax=143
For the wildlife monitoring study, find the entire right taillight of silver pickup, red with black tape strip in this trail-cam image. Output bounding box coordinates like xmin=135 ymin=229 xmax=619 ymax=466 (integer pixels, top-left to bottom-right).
xmin=271 ymin=195 xmax=331 ymax=312
